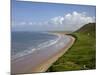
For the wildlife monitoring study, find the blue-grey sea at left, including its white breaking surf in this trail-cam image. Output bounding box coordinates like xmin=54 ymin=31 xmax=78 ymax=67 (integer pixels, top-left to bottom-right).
xmin=11 ymin=32 xmax=58 ymax=59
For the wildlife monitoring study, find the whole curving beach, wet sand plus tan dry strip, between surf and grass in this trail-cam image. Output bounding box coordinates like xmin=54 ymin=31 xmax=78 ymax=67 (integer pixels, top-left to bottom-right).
xmin=11 ymin=34 xmax=75 ymax=74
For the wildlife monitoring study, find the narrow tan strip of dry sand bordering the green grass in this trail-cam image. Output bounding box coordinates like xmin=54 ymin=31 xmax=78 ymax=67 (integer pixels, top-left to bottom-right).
xmin=33 ymin=34 xmax=75 ymax=73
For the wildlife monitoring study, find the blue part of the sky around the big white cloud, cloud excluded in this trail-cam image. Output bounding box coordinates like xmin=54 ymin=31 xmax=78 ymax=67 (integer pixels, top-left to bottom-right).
xmin=12 ymin=0 xmax=96 ymax=31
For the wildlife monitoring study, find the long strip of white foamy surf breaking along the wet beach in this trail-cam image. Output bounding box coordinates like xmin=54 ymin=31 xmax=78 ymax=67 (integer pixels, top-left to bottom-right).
xmin=11 ymin=34 xmax=61 ymax=60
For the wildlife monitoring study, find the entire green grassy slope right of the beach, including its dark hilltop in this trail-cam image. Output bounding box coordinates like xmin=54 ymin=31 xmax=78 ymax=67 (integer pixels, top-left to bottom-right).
xmin=47 ymin=23 xmax=96 ymax=72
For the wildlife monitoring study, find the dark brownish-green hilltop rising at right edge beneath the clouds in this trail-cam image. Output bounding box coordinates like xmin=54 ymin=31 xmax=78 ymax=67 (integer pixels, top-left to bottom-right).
xmin=76 ymin=23 xmax=96 ymax=36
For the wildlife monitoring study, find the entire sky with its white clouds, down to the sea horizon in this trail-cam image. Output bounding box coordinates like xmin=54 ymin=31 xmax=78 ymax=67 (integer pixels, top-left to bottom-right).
xmin=11 ymin=0 xmax=96 ymax=31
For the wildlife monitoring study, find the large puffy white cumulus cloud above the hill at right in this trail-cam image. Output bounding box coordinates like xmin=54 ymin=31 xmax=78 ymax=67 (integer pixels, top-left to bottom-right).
xmin=46 ymin=11 xmax=95 ymax=31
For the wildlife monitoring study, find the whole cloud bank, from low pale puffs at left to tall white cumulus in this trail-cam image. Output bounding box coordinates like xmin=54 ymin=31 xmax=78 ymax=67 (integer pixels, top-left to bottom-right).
xmin=12 ymin=11 xmax=95 ymax=31
